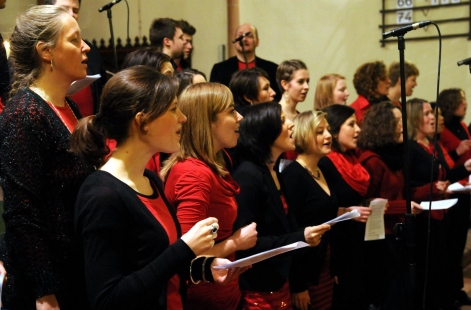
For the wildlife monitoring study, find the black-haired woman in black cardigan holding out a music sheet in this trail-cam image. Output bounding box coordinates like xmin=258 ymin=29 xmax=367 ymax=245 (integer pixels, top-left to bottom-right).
xmin=233 ymin=102 xmax=330 ymax=309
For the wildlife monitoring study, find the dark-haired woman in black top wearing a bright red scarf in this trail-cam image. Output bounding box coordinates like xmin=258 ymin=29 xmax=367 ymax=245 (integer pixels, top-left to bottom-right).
xmin=319 ymin=104 xmax=371 ymax=309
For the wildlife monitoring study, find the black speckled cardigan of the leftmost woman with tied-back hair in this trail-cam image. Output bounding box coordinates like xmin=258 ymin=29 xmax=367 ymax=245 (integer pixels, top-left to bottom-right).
xmin=0 ymin=88 xmax=93 ymax=309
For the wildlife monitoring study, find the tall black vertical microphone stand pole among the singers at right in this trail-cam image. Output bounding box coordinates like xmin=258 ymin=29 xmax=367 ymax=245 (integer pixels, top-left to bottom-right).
xmin=395 ymin=35 xmax=417 ymax=309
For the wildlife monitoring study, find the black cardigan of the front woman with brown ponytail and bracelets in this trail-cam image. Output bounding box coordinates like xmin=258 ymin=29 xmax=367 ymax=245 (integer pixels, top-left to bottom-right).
xmin=75 ymin=170 xmax=195 ymax=309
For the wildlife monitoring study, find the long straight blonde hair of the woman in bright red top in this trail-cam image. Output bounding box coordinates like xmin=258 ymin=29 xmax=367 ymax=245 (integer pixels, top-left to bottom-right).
xmin=160 ymin=82 xmax=234 ymax=180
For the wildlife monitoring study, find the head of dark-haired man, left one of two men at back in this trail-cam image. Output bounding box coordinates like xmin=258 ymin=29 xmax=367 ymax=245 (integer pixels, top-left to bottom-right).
xmin=149 ymin=18 xmax=186 ymax=69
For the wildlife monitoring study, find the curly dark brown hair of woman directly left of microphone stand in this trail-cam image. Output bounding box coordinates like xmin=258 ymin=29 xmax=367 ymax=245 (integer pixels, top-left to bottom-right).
xmin=358 ymin=101 xmax=399 ymax=150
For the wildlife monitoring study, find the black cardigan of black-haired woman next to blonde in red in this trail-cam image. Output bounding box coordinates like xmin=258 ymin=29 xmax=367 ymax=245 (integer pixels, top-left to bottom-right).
xmin=233 ymin=161 xmax=305 ymax=292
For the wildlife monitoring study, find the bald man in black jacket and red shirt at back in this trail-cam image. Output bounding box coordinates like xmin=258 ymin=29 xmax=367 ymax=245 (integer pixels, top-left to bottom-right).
xmin=209 ymin=24 xmax=281 ymax=101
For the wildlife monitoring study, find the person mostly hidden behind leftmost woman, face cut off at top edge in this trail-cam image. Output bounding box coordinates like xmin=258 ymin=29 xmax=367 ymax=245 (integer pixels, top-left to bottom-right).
xmin=44 ymin=0 xmax=106 ymax=117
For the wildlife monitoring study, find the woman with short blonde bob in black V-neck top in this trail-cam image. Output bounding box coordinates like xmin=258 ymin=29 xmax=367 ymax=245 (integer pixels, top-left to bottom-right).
xmin=281 ymin=111 xmax=338 ymax=309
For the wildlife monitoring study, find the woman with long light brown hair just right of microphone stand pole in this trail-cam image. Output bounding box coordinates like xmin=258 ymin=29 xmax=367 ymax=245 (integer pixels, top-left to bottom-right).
xmin=407 ymin=98 xmax=471 ymax=306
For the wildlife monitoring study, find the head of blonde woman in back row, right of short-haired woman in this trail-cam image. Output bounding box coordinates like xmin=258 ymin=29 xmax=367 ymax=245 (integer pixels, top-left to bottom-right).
xmin=314 ymin=73 xmax=350 ymax=110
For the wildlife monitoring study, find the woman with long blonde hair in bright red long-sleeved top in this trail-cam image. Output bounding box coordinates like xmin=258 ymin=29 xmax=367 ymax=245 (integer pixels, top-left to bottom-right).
xmin=162 ymin=83 xmax=257 ymax=309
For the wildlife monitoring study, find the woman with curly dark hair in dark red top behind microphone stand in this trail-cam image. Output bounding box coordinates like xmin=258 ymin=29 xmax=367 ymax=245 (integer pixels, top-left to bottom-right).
xmin=358 ymin=102 xmax=429 ymax=309
